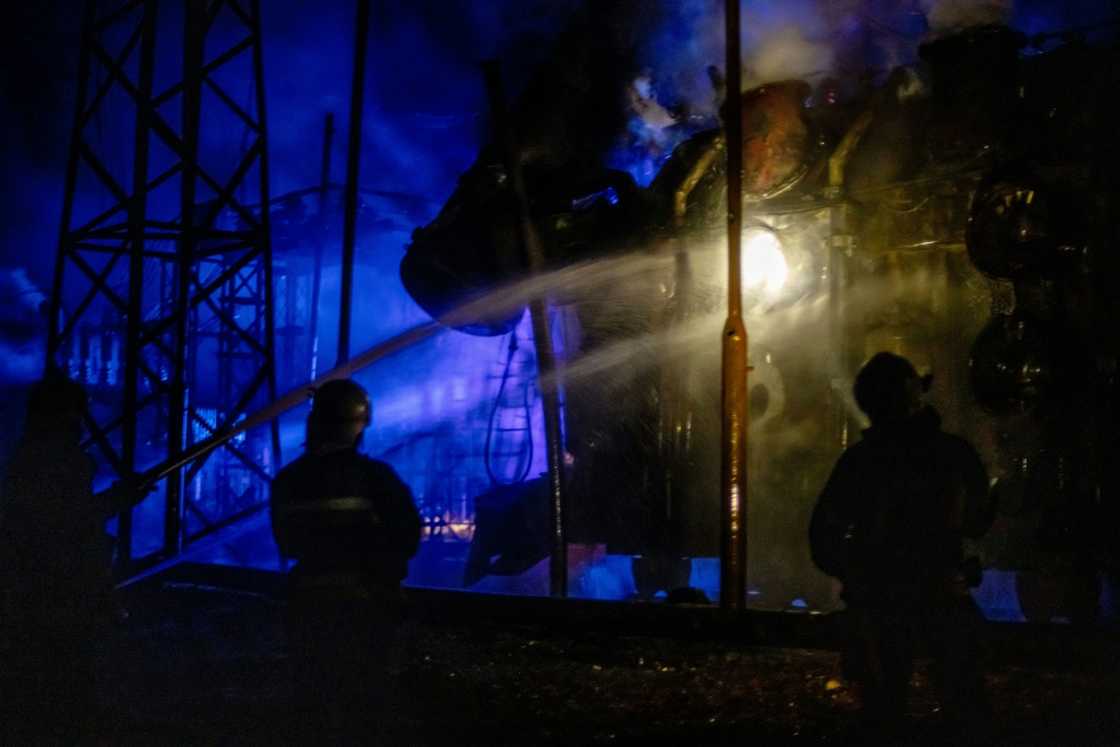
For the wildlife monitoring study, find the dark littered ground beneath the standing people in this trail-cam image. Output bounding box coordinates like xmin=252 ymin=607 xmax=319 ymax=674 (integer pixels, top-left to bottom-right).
xmin=78 ymin=568 xmax=1120 ymax=745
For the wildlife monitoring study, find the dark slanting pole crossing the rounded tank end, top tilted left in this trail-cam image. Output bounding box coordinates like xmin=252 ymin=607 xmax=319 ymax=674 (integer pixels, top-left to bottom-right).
xmin=483 ymin=60 xmax=568 ymax=597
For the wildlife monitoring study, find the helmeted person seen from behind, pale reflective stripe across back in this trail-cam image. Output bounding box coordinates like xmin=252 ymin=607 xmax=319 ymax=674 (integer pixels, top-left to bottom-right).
xmin=270 ymin=380 xmax=420 ymax=744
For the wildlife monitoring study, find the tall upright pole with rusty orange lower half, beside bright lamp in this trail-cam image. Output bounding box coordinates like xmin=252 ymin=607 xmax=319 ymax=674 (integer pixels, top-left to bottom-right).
xmin=719 ymin=0 xmax=747 ymax=610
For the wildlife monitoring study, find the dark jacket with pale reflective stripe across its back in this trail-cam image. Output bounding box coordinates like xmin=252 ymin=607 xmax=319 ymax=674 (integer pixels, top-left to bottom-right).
xmin=270 ymin=449 xmax=420 ymax=588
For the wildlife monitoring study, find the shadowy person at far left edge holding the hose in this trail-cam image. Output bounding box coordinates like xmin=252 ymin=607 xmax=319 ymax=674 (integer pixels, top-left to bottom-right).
xmin=0 ymin=370 xmax=147 ymax=745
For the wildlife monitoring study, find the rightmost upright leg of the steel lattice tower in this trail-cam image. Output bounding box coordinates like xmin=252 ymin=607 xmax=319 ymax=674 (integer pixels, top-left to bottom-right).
xmin=250 ymin=0 xmax=283 ymax=474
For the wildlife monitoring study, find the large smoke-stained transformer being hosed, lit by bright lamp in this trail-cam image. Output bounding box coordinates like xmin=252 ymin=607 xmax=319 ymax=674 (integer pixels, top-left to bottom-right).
xmin=401 ymin=19 xmax=1120 ymax=619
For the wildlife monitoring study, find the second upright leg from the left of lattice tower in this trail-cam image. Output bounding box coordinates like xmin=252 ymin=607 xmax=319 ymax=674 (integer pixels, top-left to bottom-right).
xmin=116 ymin=0 xmax=157 ymax=567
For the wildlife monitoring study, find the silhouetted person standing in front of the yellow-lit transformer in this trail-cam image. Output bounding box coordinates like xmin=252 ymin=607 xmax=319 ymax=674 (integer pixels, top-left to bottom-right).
xmin=810 ymin=353 xmax=995 ymax=729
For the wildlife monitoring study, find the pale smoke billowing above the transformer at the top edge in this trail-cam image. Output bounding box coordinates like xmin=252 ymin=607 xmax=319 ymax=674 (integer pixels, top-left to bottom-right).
xmin=612 ymin=0 xmax=1012 ymax=184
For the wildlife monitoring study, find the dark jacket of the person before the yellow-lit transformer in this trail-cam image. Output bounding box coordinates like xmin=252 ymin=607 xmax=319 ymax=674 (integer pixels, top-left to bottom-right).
xmin=810 ymin=408 xmax=995 ymax=607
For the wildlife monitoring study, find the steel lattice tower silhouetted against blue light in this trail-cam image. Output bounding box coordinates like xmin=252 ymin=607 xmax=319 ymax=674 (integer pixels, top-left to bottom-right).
xmin=48 ymin=0 xmax=280 ymax=572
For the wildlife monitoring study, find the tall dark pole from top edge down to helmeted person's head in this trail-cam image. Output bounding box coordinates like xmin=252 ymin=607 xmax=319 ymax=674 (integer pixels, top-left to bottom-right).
xmin=335 ymin=0 xmax=370 ymax=365
